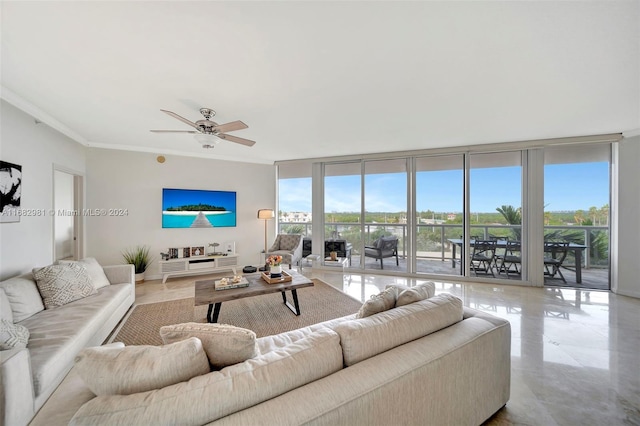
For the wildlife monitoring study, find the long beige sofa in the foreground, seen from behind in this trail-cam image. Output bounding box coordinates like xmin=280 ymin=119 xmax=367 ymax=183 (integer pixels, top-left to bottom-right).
xmin=58 ymin=294 xmax=511 ymax=425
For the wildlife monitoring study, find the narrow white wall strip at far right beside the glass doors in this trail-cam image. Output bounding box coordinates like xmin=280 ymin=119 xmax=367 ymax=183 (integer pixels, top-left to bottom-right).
xmin=613 ymin=136 xmax=640 ymax=297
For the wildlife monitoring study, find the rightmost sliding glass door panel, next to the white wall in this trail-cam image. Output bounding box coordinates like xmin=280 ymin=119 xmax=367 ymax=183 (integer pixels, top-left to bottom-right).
xmin=544 ymin=144 xmax=608 ymax=290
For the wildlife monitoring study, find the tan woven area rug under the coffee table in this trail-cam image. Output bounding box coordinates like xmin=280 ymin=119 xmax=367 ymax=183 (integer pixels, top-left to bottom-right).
xmin=109 ymin=279 xmax=362 ymax=345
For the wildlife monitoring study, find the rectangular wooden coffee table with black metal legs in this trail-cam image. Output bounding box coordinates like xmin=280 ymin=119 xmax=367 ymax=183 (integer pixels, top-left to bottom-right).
xmin=195 ymin=271 xmax=313 ymax=322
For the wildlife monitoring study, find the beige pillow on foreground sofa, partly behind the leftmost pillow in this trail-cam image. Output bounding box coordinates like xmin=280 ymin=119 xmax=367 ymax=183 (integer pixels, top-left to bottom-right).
xmin=160 ymin=322 xmax=258 ymax=369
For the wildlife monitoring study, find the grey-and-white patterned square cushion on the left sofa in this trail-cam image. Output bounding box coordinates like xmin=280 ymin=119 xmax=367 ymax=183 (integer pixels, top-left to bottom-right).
xmin=33 ymin=263 xmax=96 ymax=309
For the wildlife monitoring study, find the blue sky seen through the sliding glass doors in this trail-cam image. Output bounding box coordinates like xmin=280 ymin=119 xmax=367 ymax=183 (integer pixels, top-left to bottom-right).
xmin=279 ymin=162 xmax=609 ymax=213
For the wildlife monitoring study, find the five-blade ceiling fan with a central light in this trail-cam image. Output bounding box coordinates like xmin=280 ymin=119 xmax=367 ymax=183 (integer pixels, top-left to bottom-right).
xmin=151 ymin=108 xmax=255 ymax=148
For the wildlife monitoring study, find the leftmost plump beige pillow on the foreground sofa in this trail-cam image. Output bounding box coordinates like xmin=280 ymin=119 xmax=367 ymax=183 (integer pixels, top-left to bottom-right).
xmin=75 ymin=337 xmax=209 ymax=395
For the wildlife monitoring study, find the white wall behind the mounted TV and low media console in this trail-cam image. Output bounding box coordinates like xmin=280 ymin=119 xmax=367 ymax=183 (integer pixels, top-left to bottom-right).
xmin=86 ymin=148 xmax=275 ymax=278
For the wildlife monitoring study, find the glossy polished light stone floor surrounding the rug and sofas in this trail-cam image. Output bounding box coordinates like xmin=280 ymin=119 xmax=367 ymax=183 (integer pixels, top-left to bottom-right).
xmin=136 ymin=268 xmax=640 ymax=425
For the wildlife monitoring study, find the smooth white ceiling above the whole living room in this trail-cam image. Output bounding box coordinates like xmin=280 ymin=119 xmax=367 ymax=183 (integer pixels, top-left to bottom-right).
xmin=0 ymin=0 xmax=640 ymax=163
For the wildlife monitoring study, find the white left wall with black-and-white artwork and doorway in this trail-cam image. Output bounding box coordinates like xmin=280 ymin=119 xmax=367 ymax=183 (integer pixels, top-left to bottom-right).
xmin=0 ymin=101 xmax=85 ymax=279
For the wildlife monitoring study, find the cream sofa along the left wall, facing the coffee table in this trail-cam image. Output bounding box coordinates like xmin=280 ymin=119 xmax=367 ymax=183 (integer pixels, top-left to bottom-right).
xmin=0 ymin=265 xmax=135 ymax=426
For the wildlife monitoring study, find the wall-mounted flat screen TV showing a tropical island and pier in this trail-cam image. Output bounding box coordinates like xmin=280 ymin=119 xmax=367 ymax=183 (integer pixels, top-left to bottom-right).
xmin=162 ymin=188 xmax=236 ymax=228
